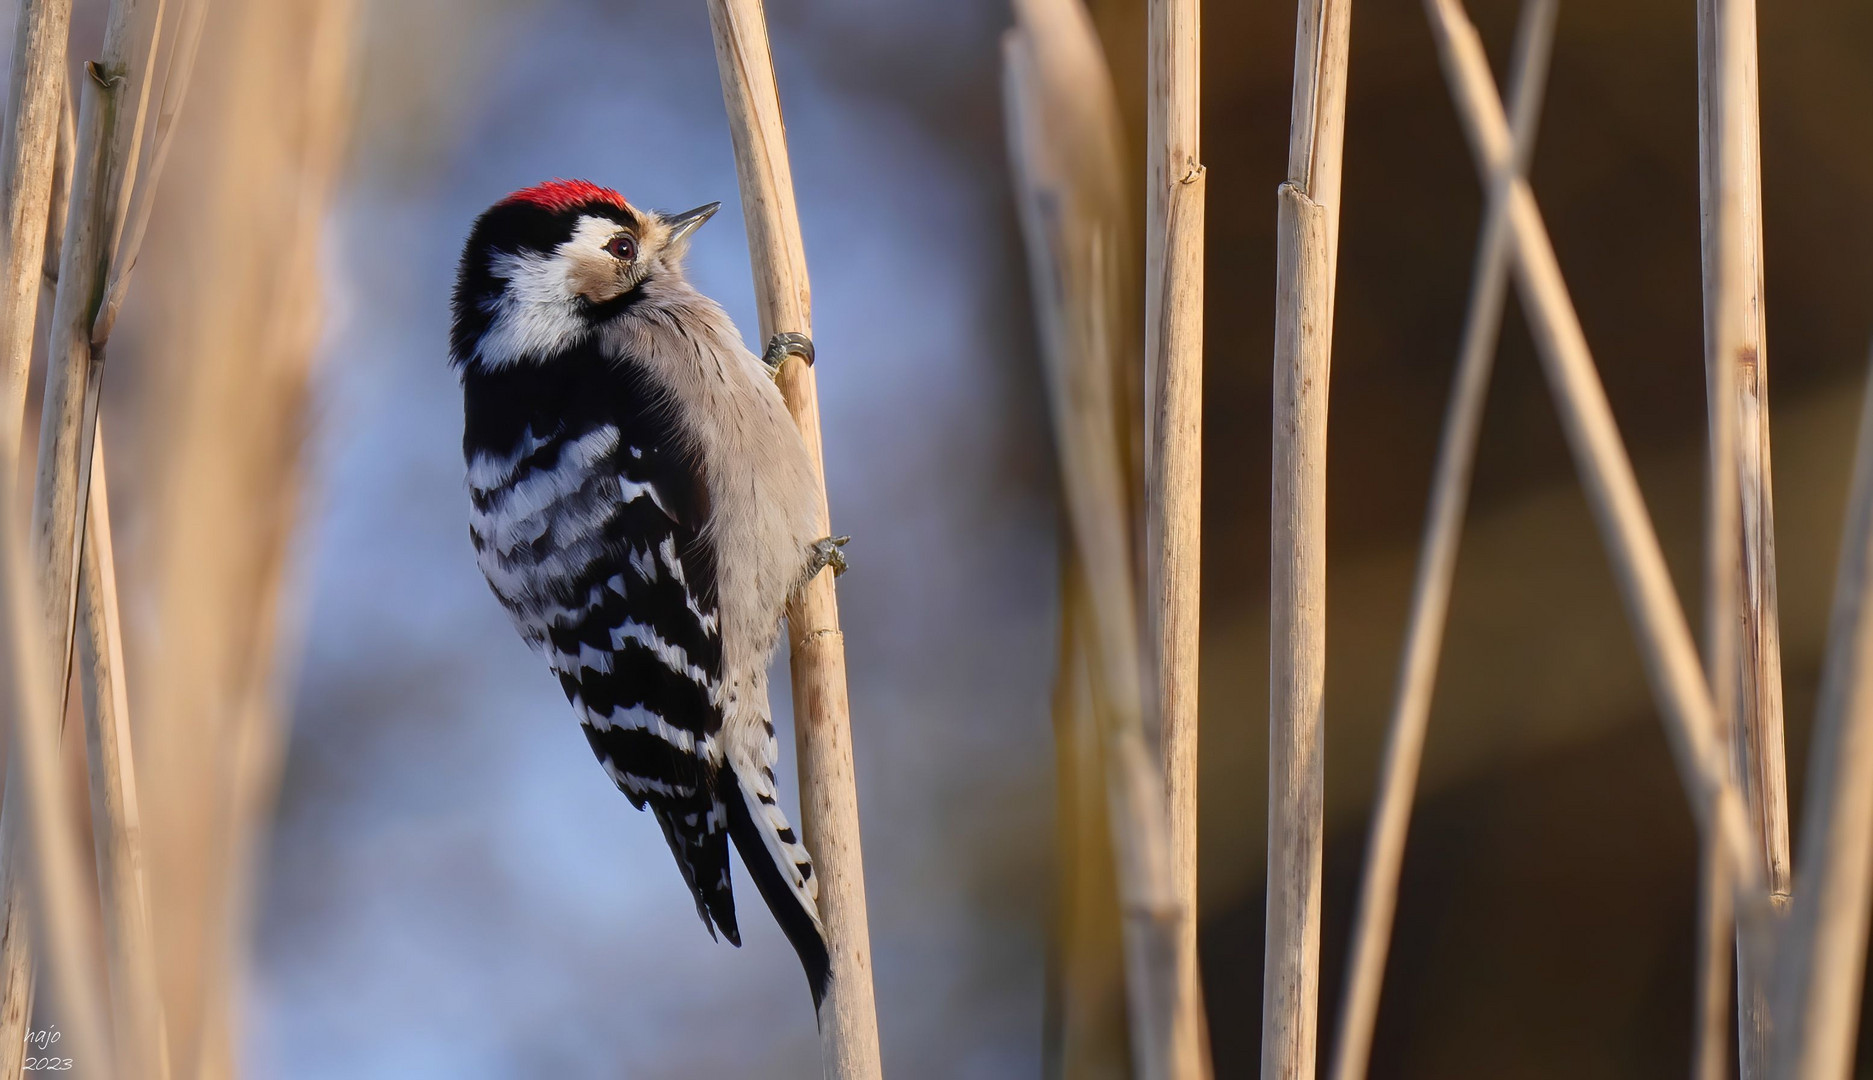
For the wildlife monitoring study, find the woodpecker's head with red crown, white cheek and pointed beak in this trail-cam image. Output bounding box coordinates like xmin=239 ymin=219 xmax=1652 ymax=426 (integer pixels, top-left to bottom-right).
xmin=451 ymin=180 xmax=721 ymax=367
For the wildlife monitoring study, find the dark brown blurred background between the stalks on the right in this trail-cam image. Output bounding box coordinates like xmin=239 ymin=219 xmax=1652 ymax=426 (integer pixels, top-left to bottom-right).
xmin=1096 ymin=0 xmax=1873 ymax=1078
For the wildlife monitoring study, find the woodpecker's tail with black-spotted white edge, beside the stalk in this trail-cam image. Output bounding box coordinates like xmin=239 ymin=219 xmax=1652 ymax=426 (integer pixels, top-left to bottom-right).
xmin=717 ymin=754 xmax=832 ymax=1011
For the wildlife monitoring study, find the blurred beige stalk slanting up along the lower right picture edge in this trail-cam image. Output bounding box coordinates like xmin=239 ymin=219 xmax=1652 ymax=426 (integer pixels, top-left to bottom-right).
xmin=1774 ymin=344 xmax=1873 ymax=1080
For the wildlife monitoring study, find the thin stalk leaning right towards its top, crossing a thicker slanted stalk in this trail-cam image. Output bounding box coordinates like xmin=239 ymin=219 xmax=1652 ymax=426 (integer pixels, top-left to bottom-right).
xmin=1332 ymin=0 xmax=1558 ymax=1080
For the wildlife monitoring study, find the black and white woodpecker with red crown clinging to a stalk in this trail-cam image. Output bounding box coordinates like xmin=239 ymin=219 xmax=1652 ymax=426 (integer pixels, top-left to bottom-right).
xmin=450 ymin=180 xmax=845 ymax=1007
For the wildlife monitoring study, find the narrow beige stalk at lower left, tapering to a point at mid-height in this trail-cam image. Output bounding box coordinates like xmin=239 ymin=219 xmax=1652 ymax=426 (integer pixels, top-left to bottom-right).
xmin=79 ymin=438 xmax=170 ymax=1080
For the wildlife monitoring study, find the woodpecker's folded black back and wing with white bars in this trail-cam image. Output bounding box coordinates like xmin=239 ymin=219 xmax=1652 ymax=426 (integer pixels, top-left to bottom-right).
xmin=463 ymin=356 xmax=740 ymax=943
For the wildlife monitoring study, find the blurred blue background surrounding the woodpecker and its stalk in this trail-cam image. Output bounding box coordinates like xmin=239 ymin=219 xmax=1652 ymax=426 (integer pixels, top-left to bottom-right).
xmin=267 ymin=0 xmax=1054 ymax=1078
